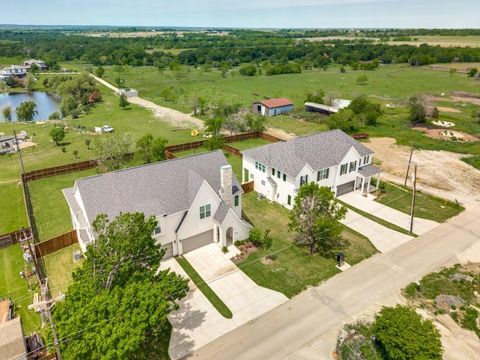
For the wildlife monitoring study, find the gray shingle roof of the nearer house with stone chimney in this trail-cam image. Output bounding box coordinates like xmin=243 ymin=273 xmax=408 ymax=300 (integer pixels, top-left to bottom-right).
xmin=71 ymin=150 xmax=241 ymax=222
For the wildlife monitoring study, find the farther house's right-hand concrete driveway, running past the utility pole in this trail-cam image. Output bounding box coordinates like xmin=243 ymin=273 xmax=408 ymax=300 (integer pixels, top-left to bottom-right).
xmin=338 ymin=191 xmax=440 ymax=235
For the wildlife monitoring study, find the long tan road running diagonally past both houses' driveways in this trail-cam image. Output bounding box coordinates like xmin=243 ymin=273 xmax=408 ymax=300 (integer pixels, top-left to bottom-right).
xmin=190 ymin=206 xmax=480 ymax=360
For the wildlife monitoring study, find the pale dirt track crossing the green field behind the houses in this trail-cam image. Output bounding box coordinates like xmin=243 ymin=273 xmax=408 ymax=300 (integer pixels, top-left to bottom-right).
xmin=90 ymin=74 xmax=204 ymax=129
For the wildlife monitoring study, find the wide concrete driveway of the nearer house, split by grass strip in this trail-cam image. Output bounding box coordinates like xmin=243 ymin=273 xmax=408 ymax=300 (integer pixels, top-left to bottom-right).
xmin=160 ymin=243 xmax=288 ymax=360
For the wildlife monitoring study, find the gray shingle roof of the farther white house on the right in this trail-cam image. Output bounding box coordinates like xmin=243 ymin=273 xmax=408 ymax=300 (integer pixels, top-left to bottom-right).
xmin=242 ymin=129 xmax=373 ymax=177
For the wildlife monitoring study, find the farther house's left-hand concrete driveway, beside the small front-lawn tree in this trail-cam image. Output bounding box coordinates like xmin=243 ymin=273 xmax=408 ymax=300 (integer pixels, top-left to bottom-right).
xmin=341 ymin=209 xmax=413 ymax=255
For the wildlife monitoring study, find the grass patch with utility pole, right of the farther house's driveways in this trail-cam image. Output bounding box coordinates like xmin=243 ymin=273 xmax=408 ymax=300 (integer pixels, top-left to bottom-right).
xmin=377 ymin=183 xmax=464 ymax=222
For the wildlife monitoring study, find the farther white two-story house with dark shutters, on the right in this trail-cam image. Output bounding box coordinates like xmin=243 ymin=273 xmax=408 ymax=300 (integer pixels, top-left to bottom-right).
xmin=242 ymin=130 xmax=380 ymax=208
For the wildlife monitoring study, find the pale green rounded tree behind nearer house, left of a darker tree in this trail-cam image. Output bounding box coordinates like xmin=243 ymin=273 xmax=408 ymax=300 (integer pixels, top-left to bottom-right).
xmin=94 ymin=134 xmax=133 ymax=171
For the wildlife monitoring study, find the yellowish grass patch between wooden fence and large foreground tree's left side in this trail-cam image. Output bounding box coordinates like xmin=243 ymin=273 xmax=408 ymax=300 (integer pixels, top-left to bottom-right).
xmin=43 ymin=244 xmax=82 ymax=296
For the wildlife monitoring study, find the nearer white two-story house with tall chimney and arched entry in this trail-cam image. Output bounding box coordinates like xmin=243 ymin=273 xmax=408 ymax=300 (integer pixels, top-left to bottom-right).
xmin=63 ymin=151 xmax=251 ymax=258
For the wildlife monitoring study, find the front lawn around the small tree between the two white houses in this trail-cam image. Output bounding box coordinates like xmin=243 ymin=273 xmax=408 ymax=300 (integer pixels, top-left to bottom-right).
xmin=237 ymin=192 xmax=376 ymax=297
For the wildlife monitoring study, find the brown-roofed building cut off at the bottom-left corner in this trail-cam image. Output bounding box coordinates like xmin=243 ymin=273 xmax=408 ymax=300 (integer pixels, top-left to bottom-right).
xmin=0 ymin=300 xmax=27 ymax=360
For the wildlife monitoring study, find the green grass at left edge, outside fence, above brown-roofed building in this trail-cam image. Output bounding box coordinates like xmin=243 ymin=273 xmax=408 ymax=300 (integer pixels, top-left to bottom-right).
xmin=0 ymin=244 xmax=41 ymax=334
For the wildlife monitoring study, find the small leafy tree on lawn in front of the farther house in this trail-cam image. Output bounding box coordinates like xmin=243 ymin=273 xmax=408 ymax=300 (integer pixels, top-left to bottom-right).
xmin=288 ymin=182 xmax=347 ymax=255
